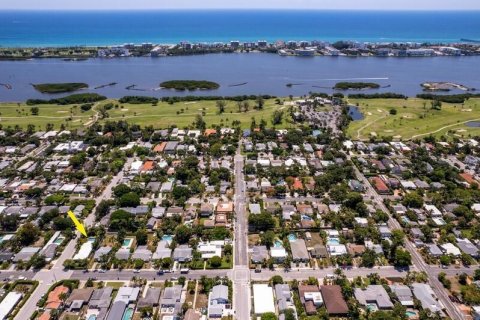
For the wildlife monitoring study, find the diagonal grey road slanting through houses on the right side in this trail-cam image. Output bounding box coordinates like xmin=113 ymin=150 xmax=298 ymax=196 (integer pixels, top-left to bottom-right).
xmin=348 ymin=157 xmax=464 ymax=320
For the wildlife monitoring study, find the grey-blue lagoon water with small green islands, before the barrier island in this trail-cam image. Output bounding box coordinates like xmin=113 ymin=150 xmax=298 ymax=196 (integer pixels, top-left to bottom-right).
xmin=0 ymin=53 xmax=480 ymax=101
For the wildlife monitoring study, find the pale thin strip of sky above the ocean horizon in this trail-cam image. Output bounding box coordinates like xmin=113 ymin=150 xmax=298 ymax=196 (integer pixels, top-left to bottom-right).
xmin=0 ymin=0 xmax=480 ymax=10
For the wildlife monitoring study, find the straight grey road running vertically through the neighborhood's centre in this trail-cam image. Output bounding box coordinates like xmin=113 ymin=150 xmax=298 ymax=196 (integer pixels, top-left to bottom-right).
xmin=233 ymin=144 xmax=250 ymax=320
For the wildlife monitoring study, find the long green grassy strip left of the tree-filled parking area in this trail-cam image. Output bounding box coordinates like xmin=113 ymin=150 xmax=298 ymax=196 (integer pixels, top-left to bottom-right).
xmin=0 ymin=99 xmax=294 ymax=130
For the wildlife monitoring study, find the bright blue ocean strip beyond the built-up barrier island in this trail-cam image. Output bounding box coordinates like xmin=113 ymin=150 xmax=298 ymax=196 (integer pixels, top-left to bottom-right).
xmin=0 ymin=10 xmax=480 ymax=47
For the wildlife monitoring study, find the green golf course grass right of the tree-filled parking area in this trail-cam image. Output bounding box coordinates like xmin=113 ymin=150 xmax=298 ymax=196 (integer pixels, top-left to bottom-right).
xmin=347 ymin=98 xmax=480 ymax=140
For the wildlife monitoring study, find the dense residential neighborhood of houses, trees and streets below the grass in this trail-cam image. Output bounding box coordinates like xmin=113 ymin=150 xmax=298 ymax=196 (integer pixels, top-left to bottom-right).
xmin=0 ymin=94 xmax=480 ymax=320
